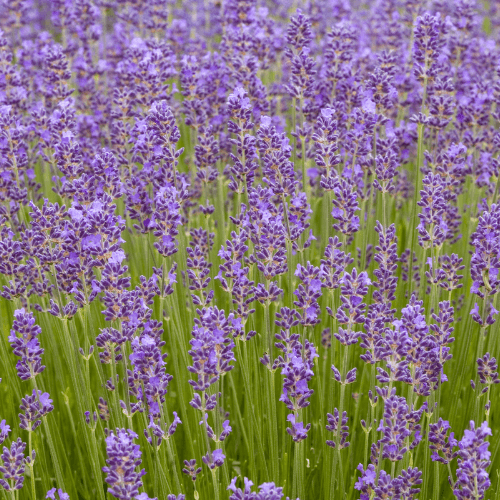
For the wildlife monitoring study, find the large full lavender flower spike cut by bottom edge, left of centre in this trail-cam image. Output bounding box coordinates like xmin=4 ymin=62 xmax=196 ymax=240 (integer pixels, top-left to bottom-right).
xmin=102 ymin=429 xmax=146 ymax=500
